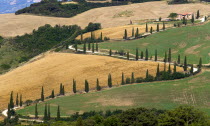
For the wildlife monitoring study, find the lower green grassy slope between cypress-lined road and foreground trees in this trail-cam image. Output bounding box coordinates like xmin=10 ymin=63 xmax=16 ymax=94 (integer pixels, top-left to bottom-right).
xmin=18 ymin=71 xmax=210 ymax=116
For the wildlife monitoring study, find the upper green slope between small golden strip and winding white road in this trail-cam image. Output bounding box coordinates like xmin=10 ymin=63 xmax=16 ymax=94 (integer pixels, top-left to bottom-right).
xmin=99 ymin=23 xmax=210 ymax=64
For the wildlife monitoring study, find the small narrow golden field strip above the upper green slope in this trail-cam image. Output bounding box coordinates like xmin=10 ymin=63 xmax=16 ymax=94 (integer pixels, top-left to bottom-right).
xmin=77 ymin=24 xmax=173 ymax=39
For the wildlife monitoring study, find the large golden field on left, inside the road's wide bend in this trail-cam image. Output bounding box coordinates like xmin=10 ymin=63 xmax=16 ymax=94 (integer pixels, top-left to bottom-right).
xmin=0 ymin=53 xmax=183 ymax=109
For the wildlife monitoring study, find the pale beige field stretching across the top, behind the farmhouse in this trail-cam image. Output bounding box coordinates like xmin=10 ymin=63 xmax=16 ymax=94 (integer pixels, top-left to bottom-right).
xmin=0 ymin=1 xmax=210 ymax=37
